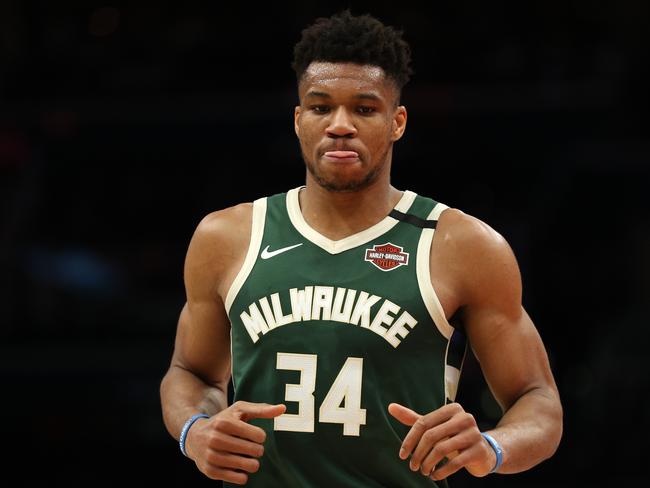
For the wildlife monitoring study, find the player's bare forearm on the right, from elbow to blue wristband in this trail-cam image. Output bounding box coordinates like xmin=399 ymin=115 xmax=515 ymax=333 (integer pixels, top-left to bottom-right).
xmin=487 ymin=388 xmax=562 ymax=474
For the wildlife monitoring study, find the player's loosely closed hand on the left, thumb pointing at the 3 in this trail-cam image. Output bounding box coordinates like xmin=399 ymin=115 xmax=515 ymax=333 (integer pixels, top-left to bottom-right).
xmin=185 ymin=401 xmax=287 ymax=485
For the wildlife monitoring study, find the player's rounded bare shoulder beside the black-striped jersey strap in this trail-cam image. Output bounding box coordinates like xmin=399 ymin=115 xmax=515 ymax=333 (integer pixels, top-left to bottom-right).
xmin=432 ymin=208 xmax=521 ymax=301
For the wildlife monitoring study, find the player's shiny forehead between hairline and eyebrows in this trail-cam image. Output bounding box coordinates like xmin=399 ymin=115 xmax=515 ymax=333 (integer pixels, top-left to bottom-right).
xmin=299 ymin=61 xmax=392 ymax=97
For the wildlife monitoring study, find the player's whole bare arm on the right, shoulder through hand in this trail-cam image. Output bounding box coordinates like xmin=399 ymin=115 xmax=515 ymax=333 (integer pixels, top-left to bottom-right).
xmin=389 ymin=210 xmax=562 ymax=479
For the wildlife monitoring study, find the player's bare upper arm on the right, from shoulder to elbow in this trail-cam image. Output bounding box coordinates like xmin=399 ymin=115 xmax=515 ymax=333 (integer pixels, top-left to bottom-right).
xmin=456 ymin=224 xmax=555 ymax=409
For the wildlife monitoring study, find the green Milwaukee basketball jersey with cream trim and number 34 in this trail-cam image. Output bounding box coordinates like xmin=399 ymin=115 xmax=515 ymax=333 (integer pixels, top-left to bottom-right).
xmin=226 ymin=188 xmax=465 ymax=488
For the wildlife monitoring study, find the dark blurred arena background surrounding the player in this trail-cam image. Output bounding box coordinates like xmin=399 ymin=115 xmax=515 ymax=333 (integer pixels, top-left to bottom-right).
xmin=0 ymin=0 xmax=650 ymax=488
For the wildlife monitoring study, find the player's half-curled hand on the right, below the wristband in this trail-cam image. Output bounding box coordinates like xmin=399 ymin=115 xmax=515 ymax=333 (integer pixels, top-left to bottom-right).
xmin=388 ymin=403 xmax=496 ymax=480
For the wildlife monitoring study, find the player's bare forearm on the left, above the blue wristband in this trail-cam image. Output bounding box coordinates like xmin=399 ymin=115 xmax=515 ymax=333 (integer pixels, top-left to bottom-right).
xmin=160 ymin=366 xmax=228 ymax=439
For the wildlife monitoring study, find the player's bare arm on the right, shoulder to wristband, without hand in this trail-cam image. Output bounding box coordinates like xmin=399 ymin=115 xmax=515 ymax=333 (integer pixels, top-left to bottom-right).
xmin=462 ymin=216 xmax=562 ymax=473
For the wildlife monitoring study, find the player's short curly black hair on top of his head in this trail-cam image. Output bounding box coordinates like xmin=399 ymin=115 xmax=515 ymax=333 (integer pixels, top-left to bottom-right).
xmin=291 ymin=9 xmax=413 ymax=92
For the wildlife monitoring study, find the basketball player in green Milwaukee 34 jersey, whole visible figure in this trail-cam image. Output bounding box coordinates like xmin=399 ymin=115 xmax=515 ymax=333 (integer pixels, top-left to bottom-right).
xmin=161 ymin=11 xmax=562 ymax=487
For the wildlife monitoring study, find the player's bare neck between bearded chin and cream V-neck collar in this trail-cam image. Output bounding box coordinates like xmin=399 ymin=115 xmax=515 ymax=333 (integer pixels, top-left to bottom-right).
xmin=299 ymin=174 xmax=402 ymax=240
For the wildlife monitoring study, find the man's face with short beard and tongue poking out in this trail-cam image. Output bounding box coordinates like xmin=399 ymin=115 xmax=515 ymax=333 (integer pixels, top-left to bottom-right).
xmin=295 ymin=62 xmax=406 ymax=191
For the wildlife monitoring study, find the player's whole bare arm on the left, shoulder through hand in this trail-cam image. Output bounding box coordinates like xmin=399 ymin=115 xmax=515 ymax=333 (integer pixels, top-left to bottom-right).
xmin=160 ymin=205 xmax=285 ymax=484
